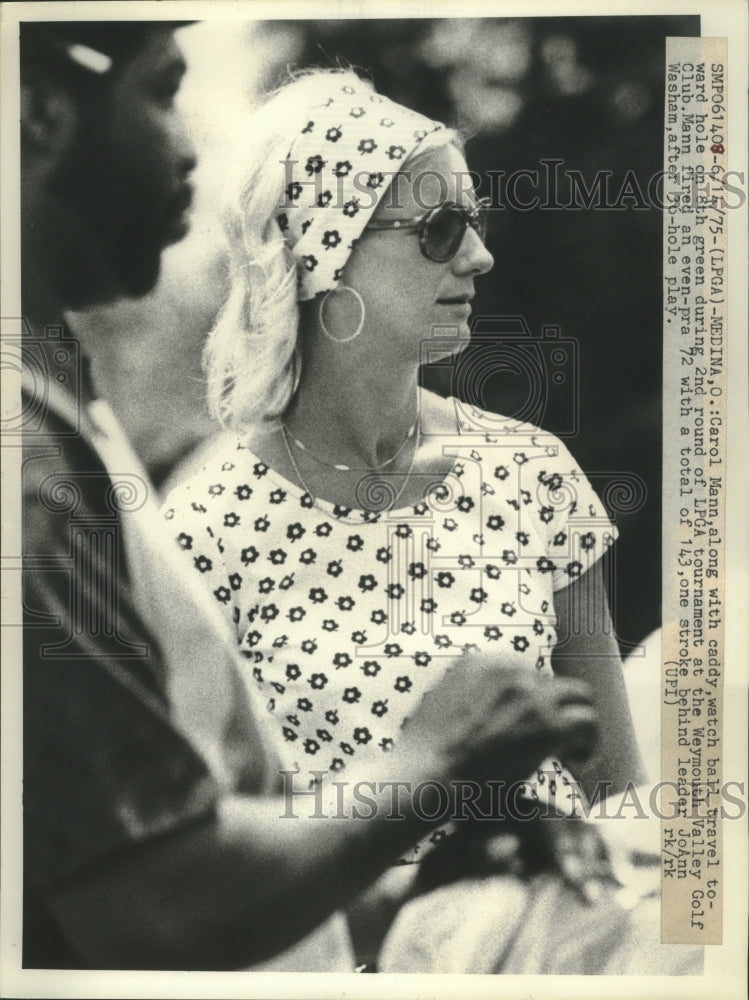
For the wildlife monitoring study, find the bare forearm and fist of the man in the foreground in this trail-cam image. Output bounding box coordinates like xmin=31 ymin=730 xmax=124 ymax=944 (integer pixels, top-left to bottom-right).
xmin=49 ymin=658 xmax=595 ymax=969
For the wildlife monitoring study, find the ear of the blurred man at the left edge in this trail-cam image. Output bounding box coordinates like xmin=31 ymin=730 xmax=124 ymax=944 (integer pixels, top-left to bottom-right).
xmin=21 ymin=67 xmax=77 ymax=158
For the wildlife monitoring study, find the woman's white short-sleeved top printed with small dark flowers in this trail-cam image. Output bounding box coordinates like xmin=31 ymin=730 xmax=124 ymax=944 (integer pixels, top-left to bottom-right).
xmin=165 ymin=412 xmax=616 ymax=828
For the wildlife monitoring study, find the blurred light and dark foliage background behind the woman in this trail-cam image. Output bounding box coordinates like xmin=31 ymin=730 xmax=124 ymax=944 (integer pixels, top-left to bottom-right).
xmin=73 ymin=16 xmax=699 ymax=651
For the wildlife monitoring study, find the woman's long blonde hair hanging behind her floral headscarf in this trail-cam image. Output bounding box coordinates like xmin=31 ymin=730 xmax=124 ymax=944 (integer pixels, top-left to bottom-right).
xmin=203 ymin=69 xmax=460 ymax=431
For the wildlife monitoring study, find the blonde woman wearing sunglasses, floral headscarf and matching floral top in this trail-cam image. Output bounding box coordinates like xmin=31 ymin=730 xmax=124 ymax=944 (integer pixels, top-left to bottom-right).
xmin=166 ymin=71 xmax=641 ymax=892
